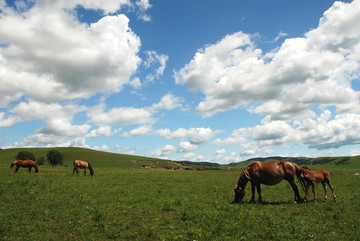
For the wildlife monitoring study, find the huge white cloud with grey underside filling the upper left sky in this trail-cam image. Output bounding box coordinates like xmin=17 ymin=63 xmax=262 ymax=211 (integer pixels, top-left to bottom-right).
xmin=0 ymin=1 xmax=141 ymax=107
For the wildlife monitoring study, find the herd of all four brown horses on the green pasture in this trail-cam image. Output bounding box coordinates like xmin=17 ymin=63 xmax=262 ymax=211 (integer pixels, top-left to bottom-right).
xmin=10 ymin=160 xmax=336 ymax=203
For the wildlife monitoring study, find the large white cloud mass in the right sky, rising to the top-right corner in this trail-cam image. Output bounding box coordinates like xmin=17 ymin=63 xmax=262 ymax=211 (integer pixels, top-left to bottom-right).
xmin=175 ymin=1 xmax=360 ymax=119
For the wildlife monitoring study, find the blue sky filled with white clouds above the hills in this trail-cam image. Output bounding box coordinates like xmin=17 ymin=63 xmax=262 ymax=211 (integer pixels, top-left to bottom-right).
xmin=0 ymin=0 xmax=360 ymax=164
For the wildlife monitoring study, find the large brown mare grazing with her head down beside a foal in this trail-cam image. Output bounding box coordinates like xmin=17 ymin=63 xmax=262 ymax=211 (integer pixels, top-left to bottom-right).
xmin=234 ymin=161 xmax=304 ymax=203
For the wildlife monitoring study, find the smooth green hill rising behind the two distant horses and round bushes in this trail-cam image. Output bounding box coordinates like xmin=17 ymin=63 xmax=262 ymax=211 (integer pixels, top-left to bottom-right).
xmin=0 ymin=147 xmax=177 ymax=169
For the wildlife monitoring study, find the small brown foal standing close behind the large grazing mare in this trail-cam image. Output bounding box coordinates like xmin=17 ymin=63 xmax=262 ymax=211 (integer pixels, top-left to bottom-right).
xmin=301 ymin=166 xmax=336 ymax=202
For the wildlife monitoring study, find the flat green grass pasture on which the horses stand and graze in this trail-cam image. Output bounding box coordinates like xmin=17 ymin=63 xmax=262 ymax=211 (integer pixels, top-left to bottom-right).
xmin=0 ymin=166 xmax=360 ymax=240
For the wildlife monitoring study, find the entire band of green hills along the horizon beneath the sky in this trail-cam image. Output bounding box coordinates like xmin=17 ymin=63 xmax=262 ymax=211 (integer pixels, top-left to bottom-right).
xmin=0 ymin=147 xmax=360 ymax=170
